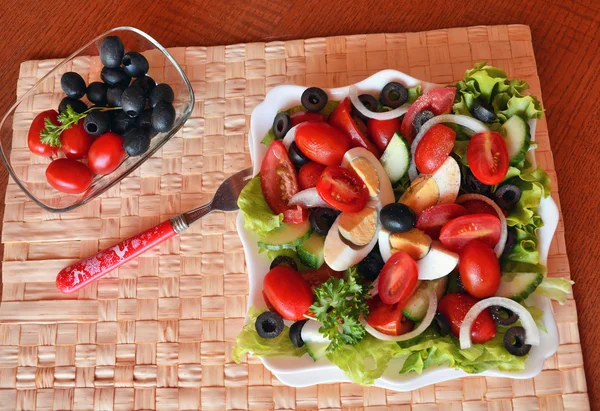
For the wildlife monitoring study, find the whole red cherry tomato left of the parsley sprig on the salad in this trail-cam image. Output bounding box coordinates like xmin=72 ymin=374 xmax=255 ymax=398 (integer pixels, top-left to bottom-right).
xmin=263 ymin=265 xmax=313 ymax=321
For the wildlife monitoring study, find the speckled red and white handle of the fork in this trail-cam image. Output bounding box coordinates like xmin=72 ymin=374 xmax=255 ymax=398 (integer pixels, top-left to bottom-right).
xmin=56 ymin=220 xmax=175 ymax=294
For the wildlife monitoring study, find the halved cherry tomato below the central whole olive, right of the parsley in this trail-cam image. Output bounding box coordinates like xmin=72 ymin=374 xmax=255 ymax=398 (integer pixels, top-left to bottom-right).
xmin=378 ymin=251 xmax=419 ymax=307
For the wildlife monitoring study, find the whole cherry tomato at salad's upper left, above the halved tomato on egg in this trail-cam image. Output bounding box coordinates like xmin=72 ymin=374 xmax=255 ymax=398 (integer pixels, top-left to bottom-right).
xmin=294 ymin=121 xmax=350 ymax=166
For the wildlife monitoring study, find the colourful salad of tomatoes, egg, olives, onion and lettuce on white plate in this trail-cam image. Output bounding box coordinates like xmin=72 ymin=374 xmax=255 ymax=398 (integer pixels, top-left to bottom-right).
xmin=233 ymin=63 xmax=571 ymax=384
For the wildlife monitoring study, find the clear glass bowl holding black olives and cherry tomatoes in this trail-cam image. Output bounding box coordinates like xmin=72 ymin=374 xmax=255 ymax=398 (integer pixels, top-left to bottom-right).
xmin=0 ymin=27 xmax=194 ymax=213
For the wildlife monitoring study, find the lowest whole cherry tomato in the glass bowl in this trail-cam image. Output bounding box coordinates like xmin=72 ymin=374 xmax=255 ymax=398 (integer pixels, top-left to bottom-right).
xmin=46 ymin=158 xmax=94 ymax=194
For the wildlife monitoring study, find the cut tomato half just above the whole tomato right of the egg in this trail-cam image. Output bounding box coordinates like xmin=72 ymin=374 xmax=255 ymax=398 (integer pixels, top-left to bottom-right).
xmin=440 ymin=214 xmax=502 ymax=253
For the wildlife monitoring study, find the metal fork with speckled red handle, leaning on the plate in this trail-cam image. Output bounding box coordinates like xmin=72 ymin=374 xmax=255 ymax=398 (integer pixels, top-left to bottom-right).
xmin=56 ymin=168 xmax=252 ymax=293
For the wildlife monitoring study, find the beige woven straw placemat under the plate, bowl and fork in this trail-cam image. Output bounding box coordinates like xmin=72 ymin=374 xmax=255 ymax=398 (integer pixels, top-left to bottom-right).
xmin=0 ymin=25 xmax=589 ymax=411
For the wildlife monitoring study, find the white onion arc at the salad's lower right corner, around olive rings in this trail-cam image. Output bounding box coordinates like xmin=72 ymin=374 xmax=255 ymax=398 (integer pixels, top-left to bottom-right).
xmin=460 ymin=297 xmax=540 ymax=349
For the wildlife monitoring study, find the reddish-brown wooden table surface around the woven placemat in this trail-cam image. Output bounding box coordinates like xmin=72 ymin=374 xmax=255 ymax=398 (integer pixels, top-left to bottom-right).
xmin=0 ymin=0 xmax=600 ymax=406
